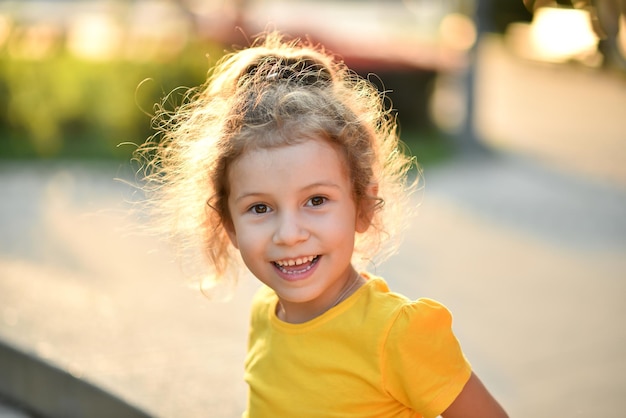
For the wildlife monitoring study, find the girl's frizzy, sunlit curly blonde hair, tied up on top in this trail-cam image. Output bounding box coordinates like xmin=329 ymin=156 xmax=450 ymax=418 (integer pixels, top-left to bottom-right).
xmin=135 ymin=32 xmax=416 ymax=285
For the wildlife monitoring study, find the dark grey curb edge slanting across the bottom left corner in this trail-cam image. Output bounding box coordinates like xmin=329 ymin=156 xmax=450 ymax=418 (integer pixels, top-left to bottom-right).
xmin=0 ymin=341 xmax=150 ymax=418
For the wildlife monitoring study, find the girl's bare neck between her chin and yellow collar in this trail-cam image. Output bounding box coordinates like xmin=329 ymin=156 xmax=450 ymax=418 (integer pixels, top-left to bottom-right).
xmin=276 ymin=270 xmax=365 ymax=324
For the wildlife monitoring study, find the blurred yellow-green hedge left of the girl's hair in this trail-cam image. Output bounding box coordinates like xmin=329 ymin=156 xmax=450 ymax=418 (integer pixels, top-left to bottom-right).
xmin=0 ymin=44 xmax=223 ymax=158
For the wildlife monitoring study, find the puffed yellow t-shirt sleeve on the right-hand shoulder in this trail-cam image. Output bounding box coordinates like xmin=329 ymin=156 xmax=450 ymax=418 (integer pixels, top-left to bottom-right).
xmin=382 ymin=299 xmax=471 ymax=417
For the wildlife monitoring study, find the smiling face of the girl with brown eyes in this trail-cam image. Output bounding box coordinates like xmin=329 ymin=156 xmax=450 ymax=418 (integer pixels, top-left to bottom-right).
xmin=227 ymin=140 xmax=368 ymax=320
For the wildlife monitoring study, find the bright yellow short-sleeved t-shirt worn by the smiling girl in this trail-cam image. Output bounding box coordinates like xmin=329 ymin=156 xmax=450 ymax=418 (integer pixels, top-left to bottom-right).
xmin=243 ymin=274 xmax=471 ymax=418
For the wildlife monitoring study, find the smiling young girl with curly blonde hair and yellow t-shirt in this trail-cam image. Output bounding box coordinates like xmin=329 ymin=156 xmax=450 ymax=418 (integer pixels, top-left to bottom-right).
xmin=139 ymin=33 xmax=506 ymax=418
